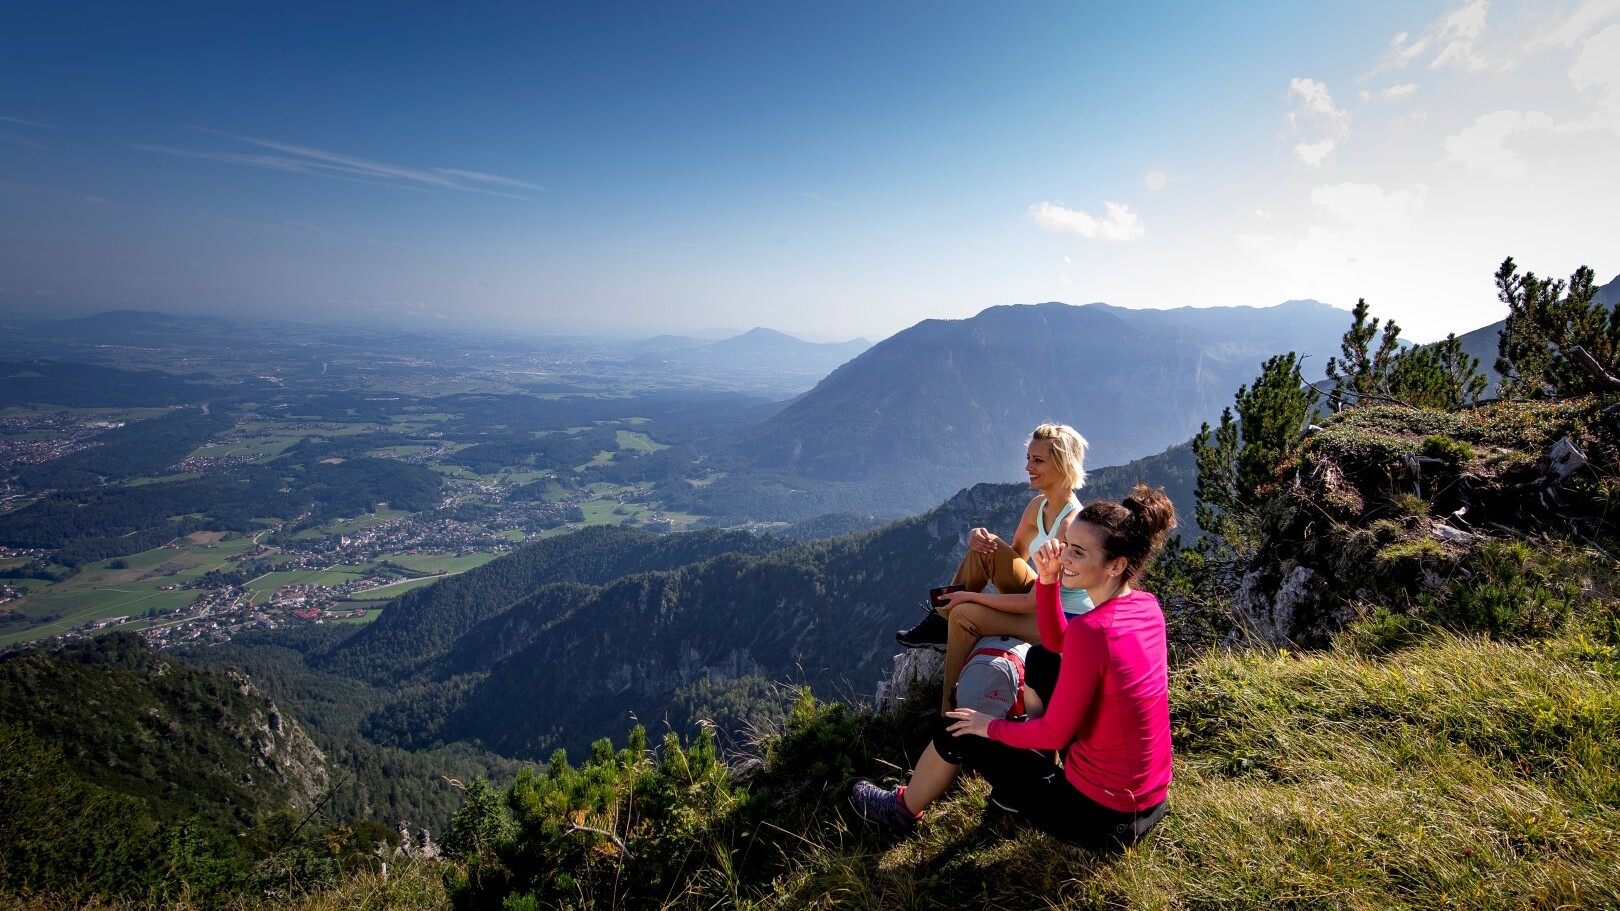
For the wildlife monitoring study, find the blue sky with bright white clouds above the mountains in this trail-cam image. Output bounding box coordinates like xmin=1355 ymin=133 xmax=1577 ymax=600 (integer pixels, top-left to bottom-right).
xmin=0 ymin=0 xmax=1620 ymax=340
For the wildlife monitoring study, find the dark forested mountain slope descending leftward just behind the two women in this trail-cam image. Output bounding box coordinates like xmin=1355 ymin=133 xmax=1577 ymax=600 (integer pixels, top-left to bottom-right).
xmin=364 ymin=446 xmax=1196 ymax=759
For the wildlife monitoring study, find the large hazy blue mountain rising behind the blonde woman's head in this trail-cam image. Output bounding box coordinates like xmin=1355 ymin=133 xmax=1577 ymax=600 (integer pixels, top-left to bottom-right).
xmin=721 ymin=302 xmax=1348 ymax=509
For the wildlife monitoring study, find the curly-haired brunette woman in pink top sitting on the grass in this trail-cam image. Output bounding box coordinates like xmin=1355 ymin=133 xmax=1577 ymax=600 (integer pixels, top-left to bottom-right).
xmin=851 ymin=486 xmax=1176 ymax=851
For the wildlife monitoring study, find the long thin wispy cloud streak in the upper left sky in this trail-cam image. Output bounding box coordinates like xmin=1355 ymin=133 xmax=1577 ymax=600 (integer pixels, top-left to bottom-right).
xmin=126 ymin=126 xmax=544 ymax=201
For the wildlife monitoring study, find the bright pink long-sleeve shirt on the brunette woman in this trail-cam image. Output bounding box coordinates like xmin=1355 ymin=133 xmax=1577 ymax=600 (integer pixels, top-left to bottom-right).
xmin=988 ymin=582 xmax=1171 ymax=812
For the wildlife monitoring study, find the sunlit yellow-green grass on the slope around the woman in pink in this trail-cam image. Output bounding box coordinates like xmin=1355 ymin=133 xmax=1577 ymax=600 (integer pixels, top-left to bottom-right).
xmin=761 ymin=631 xmax=1620 ymax=911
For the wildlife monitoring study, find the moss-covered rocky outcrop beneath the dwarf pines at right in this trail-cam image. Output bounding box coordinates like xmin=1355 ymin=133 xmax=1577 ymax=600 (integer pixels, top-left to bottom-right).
xmin=1211 ymin=399 xmax=1620 ymax=647
